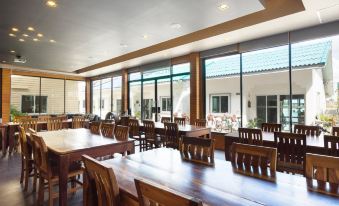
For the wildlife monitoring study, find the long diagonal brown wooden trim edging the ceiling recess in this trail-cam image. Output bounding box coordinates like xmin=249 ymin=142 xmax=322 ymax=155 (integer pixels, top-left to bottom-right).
xmin=75 ymin=0 xmax=305 ymax=74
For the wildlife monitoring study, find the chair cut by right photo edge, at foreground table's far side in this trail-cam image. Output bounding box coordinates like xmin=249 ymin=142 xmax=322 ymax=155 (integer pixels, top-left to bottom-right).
xmin=306 ymin=153 xmax=339 ymax=197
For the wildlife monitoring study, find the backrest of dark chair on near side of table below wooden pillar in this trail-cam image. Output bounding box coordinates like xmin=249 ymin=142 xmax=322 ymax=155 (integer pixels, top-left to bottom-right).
xmin=164 ymin=122 xmax=179 ymax=149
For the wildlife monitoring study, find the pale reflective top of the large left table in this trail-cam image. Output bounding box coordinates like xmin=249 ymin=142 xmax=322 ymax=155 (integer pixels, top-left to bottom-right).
xmin=38 ymin=128 xmax=134 ymax=154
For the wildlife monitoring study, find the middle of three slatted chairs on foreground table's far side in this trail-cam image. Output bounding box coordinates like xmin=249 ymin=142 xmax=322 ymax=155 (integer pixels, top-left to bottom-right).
xmin=231 ymin=142 xmax=277 ymax=181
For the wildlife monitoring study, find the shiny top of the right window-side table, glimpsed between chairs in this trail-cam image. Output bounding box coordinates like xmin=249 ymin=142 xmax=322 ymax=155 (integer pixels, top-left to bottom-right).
xmin=225 ymin=132 xmax=324 ymax=147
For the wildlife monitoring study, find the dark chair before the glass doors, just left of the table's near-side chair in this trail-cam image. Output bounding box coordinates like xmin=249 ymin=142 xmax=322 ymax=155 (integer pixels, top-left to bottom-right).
xmin=143 ymin=120 xmax=161 ymax=150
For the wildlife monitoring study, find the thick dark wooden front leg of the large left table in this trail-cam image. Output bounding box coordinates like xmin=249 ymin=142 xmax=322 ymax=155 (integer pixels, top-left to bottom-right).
xmin=58 ymin=155 xmax=69 ymax=206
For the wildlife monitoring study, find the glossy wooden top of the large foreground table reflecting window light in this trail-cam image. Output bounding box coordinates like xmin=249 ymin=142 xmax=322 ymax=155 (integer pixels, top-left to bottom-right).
xmin=103 ymin=148 xmax=339 ymax=206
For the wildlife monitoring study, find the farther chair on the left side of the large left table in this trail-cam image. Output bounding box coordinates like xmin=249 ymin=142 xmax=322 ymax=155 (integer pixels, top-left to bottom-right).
xmin=19 ymin=126 xmax=37 ymax=192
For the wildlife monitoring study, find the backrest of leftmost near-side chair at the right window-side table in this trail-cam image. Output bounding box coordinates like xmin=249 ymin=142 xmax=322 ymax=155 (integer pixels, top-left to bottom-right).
xmin=238 ymin=128 xmax=263 ymax=145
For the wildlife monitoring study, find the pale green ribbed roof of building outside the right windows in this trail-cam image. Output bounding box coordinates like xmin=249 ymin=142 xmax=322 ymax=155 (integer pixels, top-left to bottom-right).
xmin=206 ymin=40 xmax=332 ymax=78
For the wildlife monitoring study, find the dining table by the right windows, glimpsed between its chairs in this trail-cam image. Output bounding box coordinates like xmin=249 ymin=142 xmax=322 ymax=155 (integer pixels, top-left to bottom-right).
xmin=224 ymin=132 xmax=327 ymax=161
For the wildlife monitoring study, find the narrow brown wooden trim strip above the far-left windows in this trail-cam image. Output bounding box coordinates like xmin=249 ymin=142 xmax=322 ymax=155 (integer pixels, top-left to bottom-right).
xmin=12 ymin=70 xmax=86 ymax=81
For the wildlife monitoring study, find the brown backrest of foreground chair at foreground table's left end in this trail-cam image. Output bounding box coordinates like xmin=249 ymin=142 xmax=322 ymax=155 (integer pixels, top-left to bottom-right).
xmin=82 ymin=155 xmax=120 ymax=206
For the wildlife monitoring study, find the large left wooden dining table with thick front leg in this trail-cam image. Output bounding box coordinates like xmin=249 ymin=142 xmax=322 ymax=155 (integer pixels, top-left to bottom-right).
xmin=38 ymin=128 xmax=134 ymax=206
